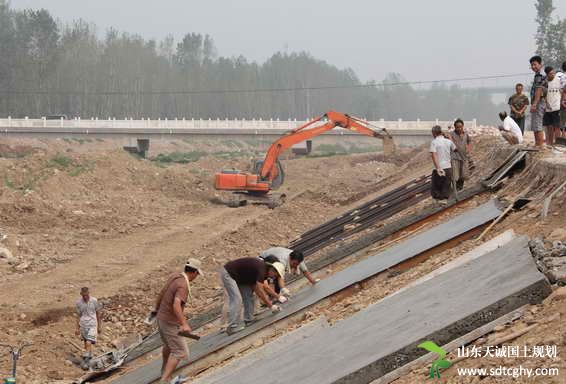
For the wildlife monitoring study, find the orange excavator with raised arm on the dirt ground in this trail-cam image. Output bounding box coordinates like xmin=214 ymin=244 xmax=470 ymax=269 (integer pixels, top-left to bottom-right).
xmin=214 ymin=111 xmax=395 ymax=208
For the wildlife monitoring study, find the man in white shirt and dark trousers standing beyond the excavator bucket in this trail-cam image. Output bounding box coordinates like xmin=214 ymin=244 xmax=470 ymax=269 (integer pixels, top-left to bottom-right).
xmin=430 ymin=125 xmax=457 ymax=204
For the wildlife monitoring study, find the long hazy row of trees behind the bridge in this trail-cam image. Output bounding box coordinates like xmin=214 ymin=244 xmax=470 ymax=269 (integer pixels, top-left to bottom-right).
xmin=0 ymin=0 xmax=564 ymax=122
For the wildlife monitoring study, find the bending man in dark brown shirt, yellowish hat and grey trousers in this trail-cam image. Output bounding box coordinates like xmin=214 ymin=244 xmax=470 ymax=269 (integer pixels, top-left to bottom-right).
xmin=220 ymin=257 xmax=287 ymax=335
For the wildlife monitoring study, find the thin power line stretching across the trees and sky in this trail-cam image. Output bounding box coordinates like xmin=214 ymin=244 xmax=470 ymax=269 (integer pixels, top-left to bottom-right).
xmin=0 ymin=73 xmax=529 ymax=96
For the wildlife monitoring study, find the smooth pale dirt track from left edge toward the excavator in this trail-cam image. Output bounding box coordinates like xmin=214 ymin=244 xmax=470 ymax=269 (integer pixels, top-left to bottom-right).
xmin=0 ymin=206 xmax=270 ymax=311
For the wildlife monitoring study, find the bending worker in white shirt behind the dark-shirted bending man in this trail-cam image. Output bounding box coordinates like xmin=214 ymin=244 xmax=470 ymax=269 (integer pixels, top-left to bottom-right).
xmin=259 ymin=247 xmax=320 ymax=297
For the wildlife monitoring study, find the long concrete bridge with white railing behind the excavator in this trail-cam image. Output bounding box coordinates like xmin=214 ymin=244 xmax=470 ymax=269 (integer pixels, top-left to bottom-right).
xmin=0 ymin=117 xmax=477 ymax=147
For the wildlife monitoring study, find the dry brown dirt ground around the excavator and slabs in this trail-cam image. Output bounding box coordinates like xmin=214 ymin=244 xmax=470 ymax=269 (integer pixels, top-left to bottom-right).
xmin=0 ymin=138 xmax=566 ymax=383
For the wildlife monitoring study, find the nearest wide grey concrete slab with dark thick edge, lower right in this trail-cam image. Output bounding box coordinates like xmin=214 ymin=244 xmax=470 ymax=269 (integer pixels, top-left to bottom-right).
xmin=199 ymin=237 xmax=551 ymax=384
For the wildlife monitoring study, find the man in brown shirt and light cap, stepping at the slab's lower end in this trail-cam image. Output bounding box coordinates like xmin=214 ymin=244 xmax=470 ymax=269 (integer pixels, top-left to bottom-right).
xmin=155 ymin=259 xmax=204 ymax=384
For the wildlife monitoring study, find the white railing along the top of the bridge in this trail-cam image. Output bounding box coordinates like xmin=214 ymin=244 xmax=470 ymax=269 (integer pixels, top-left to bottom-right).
xmin=0 ymin=117 xmax=477 ymax=130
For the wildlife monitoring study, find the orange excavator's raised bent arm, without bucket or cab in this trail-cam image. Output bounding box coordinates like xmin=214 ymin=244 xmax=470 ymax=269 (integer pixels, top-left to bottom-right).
xmin=258 ymin=111 xmax=391 ymax=181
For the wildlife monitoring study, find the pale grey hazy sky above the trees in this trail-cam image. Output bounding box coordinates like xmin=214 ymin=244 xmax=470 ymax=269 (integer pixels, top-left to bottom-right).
xmin=11 ymin=0 xmax=566 ymax=85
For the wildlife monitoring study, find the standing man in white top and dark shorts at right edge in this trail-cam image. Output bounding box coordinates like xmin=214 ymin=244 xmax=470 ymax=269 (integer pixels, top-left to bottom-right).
xmin=542 ymin=66 xmax=562 ymax=145
